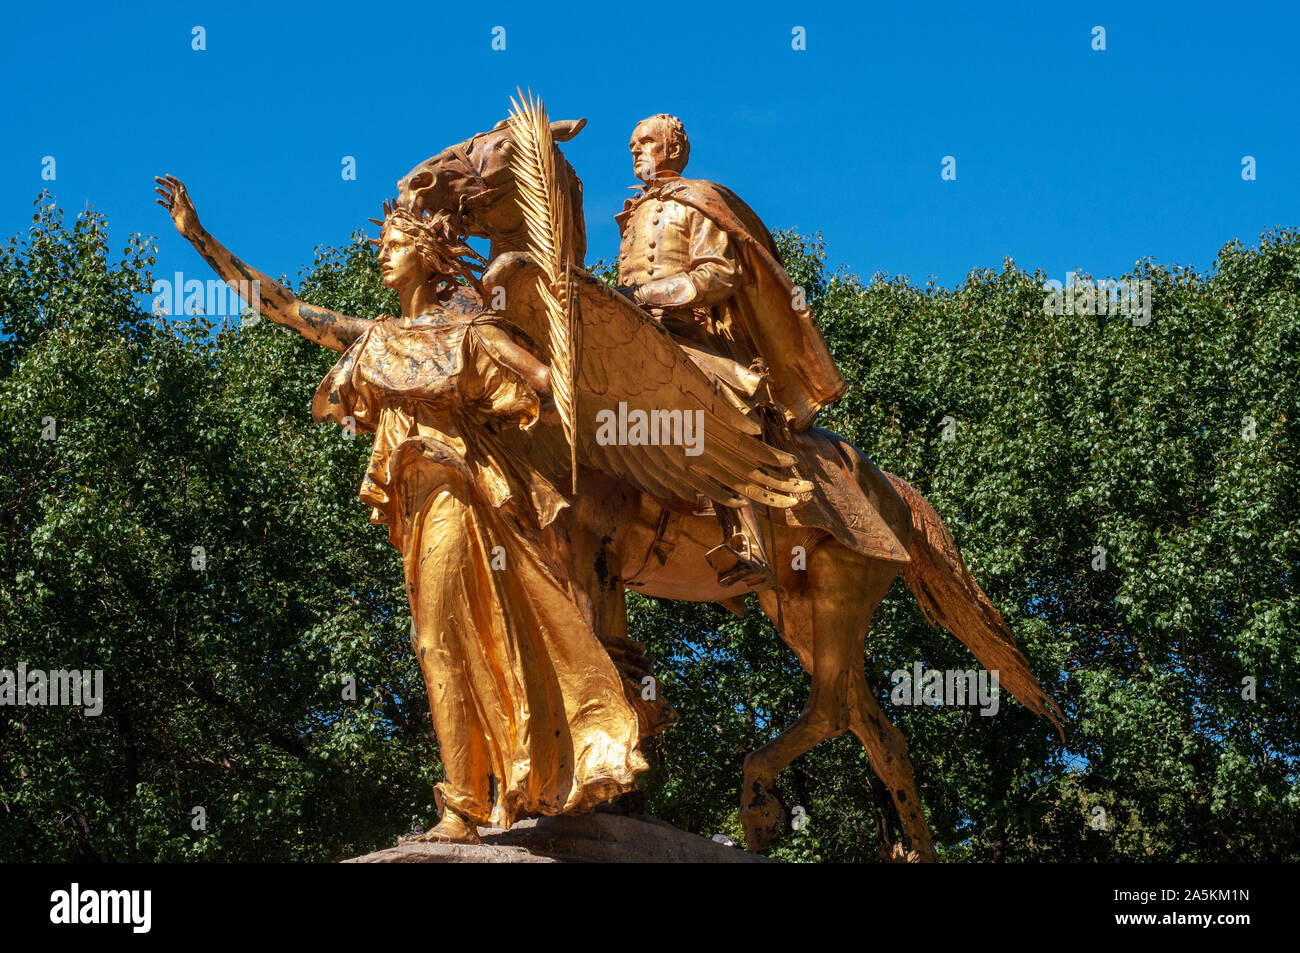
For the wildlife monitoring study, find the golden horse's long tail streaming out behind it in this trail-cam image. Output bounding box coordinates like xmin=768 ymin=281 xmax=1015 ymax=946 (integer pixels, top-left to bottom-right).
xmin=887 ymin=473 xmax=1065 ymax=741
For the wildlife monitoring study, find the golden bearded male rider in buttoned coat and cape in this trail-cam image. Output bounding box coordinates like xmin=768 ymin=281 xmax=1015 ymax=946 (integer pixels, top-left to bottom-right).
xmin=615 ymin=113 xmax=845 ymax=586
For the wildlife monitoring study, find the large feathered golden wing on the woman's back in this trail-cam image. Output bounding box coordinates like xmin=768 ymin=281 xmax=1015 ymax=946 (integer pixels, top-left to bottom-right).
xmin=482 ymin=252 xmax=813 ymax=508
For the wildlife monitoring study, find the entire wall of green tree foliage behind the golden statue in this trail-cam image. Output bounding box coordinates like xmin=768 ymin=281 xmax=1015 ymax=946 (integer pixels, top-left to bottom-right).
xmin=0 ymin=199 xmax=1300 ymax=861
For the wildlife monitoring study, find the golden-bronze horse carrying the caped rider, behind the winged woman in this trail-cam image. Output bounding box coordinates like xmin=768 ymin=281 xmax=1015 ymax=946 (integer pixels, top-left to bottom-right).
xmin=399 ymin=120 xmax=1061 ymax=861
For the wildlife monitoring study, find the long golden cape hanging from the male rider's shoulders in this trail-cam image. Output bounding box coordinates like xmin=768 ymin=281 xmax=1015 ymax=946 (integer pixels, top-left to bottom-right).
xmin=615 ymin=178 xmax=848 ymax=430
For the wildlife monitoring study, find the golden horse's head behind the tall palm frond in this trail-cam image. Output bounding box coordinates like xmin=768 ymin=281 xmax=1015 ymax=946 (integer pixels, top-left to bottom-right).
xmin=398 ymin=120 xmax=586 ymax=264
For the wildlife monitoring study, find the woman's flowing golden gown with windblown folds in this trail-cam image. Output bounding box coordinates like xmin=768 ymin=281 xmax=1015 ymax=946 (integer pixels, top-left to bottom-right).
xmin=312 ymin=309 xmax=646 ymax=827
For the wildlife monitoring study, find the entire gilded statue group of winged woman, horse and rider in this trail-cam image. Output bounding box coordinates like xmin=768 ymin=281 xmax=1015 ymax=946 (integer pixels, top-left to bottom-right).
xmin=157 ymin=96 xmax=1060 ymax=861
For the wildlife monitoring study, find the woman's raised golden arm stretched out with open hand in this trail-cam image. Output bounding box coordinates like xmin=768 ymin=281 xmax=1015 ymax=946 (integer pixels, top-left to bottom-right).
xmin=153 ymin=176 xmax=372 ymax=351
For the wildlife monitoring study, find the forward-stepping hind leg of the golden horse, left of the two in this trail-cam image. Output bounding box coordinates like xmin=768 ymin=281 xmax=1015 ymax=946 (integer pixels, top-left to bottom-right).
xmin=740 ymin=543 xmax=897 ymax=850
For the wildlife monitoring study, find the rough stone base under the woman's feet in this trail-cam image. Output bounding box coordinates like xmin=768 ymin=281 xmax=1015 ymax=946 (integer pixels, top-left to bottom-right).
xmin=343 ymin=814 xmax=772 ymax=863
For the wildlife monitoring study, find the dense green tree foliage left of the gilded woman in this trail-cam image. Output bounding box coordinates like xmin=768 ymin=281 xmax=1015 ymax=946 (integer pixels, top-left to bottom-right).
xmin=0 ymin=197 xmax=438 ymax=859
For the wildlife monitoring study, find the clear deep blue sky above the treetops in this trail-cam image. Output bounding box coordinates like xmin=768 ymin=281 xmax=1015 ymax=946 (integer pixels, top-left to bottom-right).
xmin=0 ymin=0 xmax=1300 ymax=285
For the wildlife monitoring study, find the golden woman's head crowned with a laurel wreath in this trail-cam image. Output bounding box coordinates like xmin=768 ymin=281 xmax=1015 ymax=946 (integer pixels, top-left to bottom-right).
xmin=371 ymin=203 xmax=478 ymax=296
